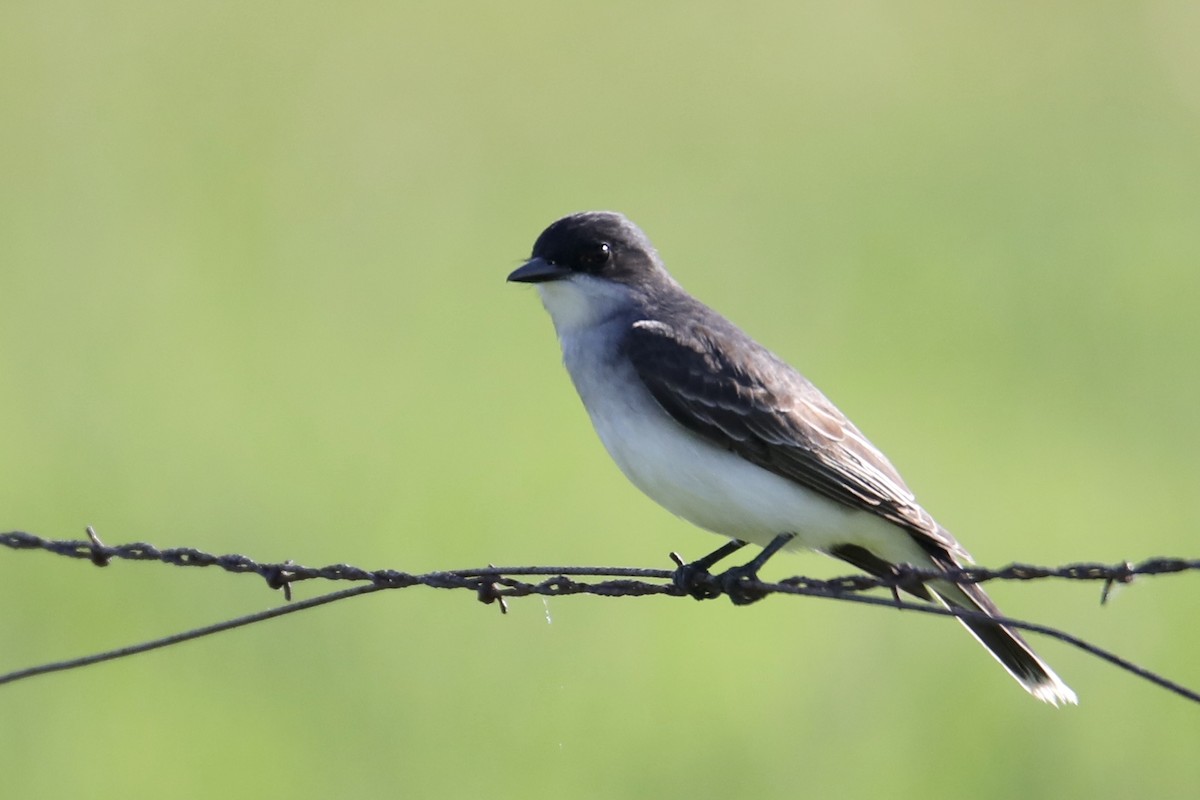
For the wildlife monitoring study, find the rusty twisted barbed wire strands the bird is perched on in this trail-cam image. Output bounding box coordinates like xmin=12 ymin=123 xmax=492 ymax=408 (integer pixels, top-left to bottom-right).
xmin=0 ymin=527 xmax=1200 ymax=703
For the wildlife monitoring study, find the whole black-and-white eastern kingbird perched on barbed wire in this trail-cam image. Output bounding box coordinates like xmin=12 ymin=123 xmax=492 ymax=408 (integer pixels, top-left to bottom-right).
xmin=508 ymin=211 xmax=1076 ymax=705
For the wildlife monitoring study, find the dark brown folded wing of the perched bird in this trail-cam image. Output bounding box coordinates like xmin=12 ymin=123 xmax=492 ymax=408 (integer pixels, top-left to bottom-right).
xmin=623 ymin=319 xmax=970 ymax=559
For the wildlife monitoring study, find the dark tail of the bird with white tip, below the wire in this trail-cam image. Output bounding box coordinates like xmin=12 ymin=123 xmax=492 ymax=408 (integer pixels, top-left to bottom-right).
xmin=928 ymin=581 xmax=1079 ymax=705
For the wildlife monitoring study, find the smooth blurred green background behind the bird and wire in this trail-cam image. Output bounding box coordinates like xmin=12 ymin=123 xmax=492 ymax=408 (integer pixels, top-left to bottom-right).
xmin=0 ymin=0 xmax=1200 ymax=798
